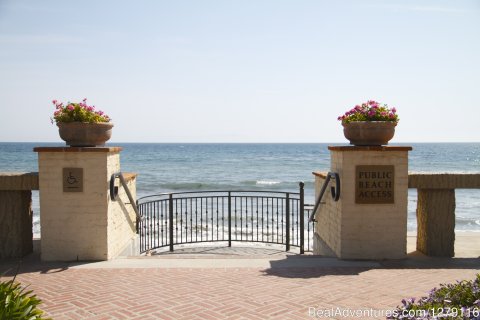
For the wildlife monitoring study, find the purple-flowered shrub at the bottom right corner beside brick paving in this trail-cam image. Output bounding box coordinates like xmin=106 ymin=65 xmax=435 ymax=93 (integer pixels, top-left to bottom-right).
xmin=388 ymin=274 xmax=480 ymax=319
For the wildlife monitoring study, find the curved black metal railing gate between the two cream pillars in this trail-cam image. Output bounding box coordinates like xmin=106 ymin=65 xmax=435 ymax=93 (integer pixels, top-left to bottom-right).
xmin=137 ymin=183 xmax=314 ymax=253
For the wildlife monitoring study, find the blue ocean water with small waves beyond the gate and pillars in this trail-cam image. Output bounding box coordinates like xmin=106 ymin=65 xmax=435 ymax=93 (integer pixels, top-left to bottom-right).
xmin=0 ymin=143 xmax=480 ymax=236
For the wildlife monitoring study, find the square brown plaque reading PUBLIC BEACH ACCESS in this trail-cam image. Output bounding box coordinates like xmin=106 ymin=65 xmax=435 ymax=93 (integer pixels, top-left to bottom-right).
xmin=355 ymin=165 xmax=395 ymax=204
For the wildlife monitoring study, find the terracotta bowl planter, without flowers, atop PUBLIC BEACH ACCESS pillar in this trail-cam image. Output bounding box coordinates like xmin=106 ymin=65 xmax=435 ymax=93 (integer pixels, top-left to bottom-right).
xmin=343 ymin=121 xmax=397 ymax=146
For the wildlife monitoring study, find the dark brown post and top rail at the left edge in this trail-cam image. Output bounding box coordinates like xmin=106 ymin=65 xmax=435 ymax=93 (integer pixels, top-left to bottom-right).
xmin=0 ymin=172 xmax=38 ymax=260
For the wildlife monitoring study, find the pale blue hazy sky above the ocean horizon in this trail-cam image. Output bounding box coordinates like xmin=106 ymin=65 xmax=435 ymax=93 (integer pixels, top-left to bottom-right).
xmin=0 ymin=0 xmax=480 ymax=143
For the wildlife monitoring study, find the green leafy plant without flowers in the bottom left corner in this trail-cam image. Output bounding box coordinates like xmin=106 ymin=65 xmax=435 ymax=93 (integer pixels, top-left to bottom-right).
xmin=0 ymin=280 xmax=47 ymax=320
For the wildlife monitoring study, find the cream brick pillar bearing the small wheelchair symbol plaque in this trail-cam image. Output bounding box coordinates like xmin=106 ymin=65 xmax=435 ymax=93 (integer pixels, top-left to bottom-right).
xmin=34 ymin=147 xmax=136 ymax=261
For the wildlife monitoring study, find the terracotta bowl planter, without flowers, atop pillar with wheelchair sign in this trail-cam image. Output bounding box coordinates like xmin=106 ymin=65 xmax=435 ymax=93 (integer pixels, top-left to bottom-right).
xmin=57 ymin=122 xmax=113 ymax=147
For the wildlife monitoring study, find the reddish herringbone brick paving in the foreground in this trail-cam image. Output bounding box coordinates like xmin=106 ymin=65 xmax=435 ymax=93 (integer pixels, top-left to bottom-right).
xmin=0 ymin=250 xmax=480 ymax=320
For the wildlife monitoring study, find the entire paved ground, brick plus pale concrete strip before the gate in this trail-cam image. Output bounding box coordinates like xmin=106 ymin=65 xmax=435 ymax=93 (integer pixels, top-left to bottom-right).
xmin=0 ymin=234 xmax=480 ymax=319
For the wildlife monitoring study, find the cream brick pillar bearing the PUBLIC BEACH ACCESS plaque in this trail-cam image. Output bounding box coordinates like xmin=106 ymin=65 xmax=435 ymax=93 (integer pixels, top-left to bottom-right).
xmin=314 ymin=146 xmax=412 ymax=260
